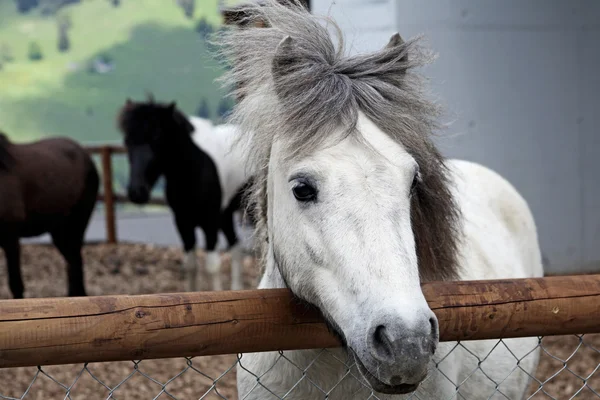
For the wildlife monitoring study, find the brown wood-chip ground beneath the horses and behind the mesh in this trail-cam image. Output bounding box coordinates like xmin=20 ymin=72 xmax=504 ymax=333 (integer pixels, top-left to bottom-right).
xmin=0 ymin=244 xmax=600 ymax=400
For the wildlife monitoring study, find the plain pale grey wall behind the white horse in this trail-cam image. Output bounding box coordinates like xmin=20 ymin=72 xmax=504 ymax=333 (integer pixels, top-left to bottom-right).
xmin=312 ymin=0 xmax=600 ymax=273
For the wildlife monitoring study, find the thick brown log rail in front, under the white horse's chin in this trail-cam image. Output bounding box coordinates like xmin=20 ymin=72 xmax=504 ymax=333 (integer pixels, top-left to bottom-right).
xmin=0 ymin=275 xmax=600 ymax=368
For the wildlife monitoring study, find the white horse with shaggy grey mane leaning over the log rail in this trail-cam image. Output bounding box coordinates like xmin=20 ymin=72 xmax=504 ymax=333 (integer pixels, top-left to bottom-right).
xmin=221 ymin=0 xmax=543 ymax=400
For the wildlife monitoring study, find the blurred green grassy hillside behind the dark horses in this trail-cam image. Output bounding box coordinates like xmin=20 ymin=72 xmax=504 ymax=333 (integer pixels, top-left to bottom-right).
xmin=0 ymin=0 xmax=230 ymax=142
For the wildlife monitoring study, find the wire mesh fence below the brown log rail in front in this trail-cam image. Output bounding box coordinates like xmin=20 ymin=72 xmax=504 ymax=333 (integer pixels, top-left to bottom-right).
xmin=0 ymin=334 xmax=600 ymax=400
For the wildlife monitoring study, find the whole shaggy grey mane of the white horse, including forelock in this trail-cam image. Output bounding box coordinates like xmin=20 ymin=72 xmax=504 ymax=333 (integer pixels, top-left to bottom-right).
xmin=217 ymin=0 xmax=458 ymax=279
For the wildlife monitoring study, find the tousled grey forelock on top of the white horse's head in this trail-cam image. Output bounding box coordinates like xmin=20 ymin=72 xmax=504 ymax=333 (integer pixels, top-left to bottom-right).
xmin=216 ymin=0 xmax=440 ymax=166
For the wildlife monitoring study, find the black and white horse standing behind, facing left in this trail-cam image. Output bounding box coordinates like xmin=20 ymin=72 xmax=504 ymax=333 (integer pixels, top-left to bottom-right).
xmin=118 ymin=98 xmax=250 ymax=291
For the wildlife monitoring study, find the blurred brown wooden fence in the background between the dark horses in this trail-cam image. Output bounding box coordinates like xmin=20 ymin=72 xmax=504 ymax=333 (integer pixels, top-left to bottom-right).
xmin=86 ymin=145 xmax=167 ymax=244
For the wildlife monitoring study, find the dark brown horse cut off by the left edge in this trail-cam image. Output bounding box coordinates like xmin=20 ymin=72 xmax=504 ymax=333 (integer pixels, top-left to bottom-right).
xmin=0 ymin=132 xmax=100 ymax=298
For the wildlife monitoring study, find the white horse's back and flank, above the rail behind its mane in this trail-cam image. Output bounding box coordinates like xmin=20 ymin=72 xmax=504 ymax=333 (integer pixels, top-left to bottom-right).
xmin=449 ymin=160 xmax=543 ymax=280
